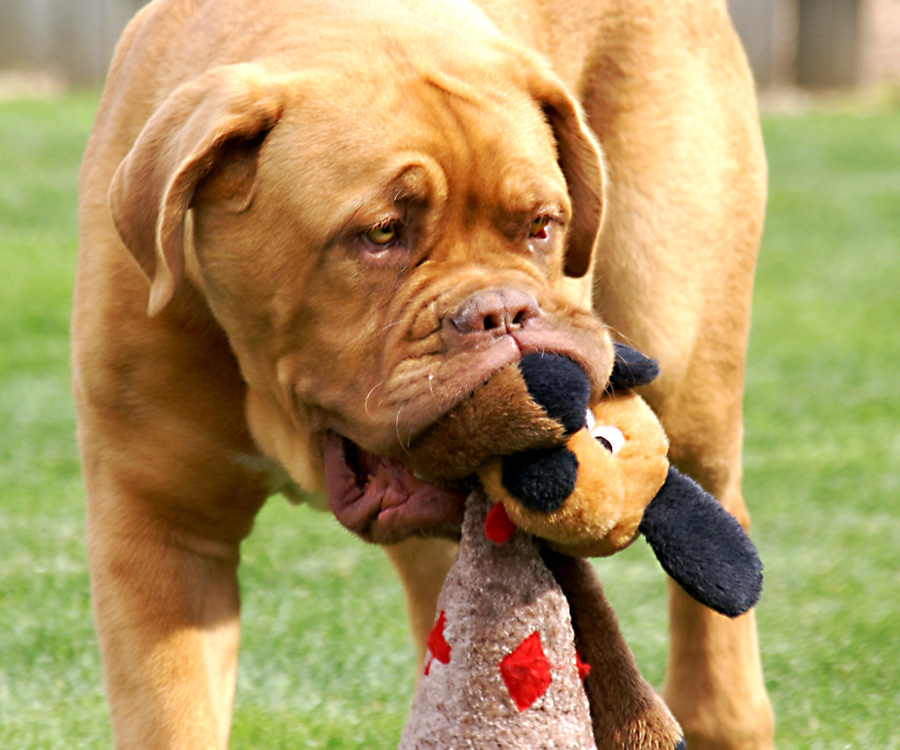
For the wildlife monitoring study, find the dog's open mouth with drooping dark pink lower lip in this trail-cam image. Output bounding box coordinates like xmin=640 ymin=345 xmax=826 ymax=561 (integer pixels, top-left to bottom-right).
xmin=321 ymin=432 xmax=466 ymax=544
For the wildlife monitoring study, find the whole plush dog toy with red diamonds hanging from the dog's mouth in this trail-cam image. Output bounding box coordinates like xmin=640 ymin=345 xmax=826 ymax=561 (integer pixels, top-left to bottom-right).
xmin=400 ymin=345 xmax=761 ymax=750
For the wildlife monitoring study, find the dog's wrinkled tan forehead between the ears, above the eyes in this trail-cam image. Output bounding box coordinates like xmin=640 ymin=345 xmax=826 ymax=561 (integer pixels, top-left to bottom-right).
xmin=270 ymin=65 xmax=566 ymax=217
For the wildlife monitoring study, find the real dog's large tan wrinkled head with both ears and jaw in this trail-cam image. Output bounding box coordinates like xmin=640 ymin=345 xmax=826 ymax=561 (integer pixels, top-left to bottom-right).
xmin=110 ymin=26 xmax=612 ymax=541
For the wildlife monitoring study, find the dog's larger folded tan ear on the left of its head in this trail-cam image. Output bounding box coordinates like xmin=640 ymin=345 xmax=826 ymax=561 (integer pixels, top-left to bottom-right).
xmin=109 ymin=64 xmax=283 ymax=315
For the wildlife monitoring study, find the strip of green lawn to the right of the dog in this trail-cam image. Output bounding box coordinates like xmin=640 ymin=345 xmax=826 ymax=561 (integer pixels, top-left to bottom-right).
xmin=745 ymin=111 xmax=900 ymax=748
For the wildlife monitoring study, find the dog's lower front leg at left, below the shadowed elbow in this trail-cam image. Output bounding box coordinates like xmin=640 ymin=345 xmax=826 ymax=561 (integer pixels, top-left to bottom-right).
xmin=88 ymin=484 xmax=256 ymax=750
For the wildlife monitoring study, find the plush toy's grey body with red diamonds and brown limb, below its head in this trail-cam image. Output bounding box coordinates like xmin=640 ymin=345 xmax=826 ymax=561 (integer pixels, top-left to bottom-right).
xmin=399 ymin=492 xmax=681 ymax=750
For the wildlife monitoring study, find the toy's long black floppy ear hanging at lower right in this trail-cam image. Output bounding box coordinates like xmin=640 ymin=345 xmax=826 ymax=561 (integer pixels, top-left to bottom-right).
xmin=638 ymin=467 xmax=762 ymax=617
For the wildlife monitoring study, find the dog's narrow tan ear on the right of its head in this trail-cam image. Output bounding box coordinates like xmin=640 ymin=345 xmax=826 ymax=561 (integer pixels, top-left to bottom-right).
xmin=530 ymin=67 xmax=605 ymax=278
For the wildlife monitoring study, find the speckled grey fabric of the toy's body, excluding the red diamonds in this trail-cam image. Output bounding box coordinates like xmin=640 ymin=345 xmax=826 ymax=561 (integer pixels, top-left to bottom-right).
xmin=399 ymin=493 xmax=596 ymax=750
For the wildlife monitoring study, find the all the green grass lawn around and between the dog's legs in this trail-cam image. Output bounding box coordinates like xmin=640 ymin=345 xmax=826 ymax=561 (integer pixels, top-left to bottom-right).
xmin=0 ymin=95 xmax=900 ymax=750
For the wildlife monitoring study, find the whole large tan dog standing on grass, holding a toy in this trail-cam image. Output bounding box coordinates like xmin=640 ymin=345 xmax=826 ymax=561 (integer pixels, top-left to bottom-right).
xmin=73 ymin=0 xmax=772 ymax=750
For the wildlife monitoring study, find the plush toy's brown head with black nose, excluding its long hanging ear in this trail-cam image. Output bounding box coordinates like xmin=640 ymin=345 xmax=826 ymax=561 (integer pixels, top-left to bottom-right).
xmin=408 ymin=347 xmax=668 ymax=556
